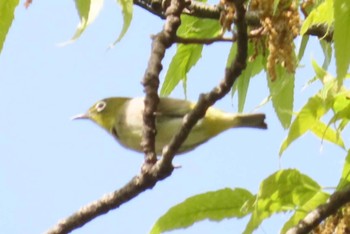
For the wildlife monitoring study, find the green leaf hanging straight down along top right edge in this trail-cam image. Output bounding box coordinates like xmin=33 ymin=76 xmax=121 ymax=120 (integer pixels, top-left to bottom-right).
xmin=329 ymin=0 xmax=350 ymax=83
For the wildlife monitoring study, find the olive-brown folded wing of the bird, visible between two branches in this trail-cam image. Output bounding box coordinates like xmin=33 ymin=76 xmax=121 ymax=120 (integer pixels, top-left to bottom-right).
xmin=156 ymin=98 xmax=194 ymax=118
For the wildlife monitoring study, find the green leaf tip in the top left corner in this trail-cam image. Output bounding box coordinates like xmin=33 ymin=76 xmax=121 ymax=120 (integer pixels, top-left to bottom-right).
xmin=0 ymin=0 xmax=19 ymax=53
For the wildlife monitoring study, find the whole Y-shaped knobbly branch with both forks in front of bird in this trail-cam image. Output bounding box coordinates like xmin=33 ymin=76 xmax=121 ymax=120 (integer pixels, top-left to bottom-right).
xmin=47 ymin=0 xmax=248 ymax=234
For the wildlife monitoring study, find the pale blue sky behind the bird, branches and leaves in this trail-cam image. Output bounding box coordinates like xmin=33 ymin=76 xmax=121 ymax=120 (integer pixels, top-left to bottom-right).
xmin=0 ymin=1 xmax=348 ymax=234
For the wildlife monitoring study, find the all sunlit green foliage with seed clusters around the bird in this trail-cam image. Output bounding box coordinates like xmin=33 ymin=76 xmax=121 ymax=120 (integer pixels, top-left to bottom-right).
xmin=0 ymin=0 xmax=350 ymax=233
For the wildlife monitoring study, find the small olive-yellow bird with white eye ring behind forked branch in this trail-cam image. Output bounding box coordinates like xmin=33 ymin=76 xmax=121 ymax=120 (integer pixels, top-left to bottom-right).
xmin=72 ymin=97 xmax=267 ymax=155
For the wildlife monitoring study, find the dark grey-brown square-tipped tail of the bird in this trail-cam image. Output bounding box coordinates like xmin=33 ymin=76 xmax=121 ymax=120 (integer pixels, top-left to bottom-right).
xmin=234 ymin=113 xmax=267 ymax=129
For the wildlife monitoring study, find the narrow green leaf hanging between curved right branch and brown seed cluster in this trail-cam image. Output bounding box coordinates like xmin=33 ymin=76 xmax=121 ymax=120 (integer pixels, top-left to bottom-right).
xmin=229 ymin=43 xmax=264 ymax=112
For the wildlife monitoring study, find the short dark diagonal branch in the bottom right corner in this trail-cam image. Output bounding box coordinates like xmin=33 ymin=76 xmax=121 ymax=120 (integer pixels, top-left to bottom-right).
xmin=287 ymin=189 xmax=350 ymax=234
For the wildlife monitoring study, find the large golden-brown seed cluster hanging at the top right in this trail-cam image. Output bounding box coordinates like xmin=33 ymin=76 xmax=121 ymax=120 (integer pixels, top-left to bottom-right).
xmin=249 ymin=0 xmax=301 ymax=80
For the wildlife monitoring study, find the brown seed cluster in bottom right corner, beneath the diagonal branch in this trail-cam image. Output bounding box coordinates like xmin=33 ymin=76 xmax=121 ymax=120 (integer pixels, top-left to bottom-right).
xmin=312 ymin=203 xmax=350 ymax=234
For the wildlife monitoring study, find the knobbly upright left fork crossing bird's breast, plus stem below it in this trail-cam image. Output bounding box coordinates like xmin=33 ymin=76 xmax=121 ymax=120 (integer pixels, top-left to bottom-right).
xmin=47 ymin=0 xmax=185 ymax=234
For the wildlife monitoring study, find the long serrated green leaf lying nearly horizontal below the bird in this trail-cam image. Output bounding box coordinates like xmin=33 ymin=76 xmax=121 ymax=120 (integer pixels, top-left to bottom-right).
xmin=150 ymin=188 xmax=254 ymax=234
